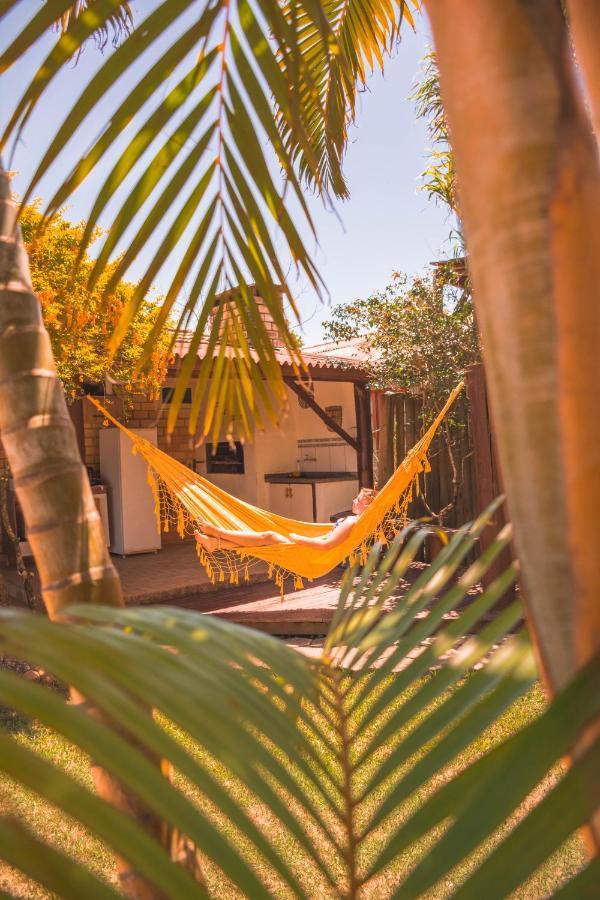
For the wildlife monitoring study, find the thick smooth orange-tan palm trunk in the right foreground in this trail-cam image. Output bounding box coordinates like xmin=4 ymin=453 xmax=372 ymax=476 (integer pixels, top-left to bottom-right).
xmin=427 ymin=0 xmax=600 ymax=844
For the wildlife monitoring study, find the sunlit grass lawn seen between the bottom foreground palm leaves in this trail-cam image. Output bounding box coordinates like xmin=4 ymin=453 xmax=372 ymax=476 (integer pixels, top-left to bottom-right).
xmin=0 ymin=686 xmax=584 ymax=900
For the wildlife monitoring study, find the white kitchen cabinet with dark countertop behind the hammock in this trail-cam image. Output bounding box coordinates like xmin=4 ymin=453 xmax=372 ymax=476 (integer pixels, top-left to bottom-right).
xmin=265 ymin=472 xmax=358 ymax=522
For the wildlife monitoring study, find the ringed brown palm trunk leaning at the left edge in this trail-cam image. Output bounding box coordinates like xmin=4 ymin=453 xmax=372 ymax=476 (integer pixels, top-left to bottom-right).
xmin=0 ymin=166 xmax=171 ymax=900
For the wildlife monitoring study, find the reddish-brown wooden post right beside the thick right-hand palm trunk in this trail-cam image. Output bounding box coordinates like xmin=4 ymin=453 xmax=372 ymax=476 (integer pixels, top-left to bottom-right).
xmin=467 ymin=363 xmax=514 ymax=603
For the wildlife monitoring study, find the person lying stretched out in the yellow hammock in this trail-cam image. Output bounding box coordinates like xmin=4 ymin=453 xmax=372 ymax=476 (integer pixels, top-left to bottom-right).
xmin=194 ymin=488 xmax=376 ymax=553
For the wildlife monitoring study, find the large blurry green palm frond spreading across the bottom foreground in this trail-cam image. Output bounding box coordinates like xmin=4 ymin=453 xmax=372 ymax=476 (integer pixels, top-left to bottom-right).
xmin=0 ymin=516 xmax=600 ymax=898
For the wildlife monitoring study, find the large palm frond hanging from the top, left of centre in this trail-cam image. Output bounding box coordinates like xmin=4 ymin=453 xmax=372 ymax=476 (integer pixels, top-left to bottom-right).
xmin=0 ymin=0 xmax=342 ymax=437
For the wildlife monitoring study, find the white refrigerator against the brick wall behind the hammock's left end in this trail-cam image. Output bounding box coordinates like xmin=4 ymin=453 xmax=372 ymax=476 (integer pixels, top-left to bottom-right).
xmin=100 ymin=428 xmax=161 ymax=556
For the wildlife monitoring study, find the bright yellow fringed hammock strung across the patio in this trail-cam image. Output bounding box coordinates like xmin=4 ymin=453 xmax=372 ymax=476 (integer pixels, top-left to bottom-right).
xmin=88 ymin=382 xmax=463 ymax=595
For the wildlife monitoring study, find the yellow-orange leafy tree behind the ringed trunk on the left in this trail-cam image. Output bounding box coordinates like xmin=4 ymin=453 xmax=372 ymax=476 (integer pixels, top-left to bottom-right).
xmin=21 ymin=203 xmax=168 ymax=398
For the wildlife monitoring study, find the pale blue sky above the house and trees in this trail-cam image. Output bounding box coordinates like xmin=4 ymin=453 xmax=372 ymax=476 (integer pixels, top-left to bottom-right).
xmin=0 ymin=0 xmax=451 ymax=343
